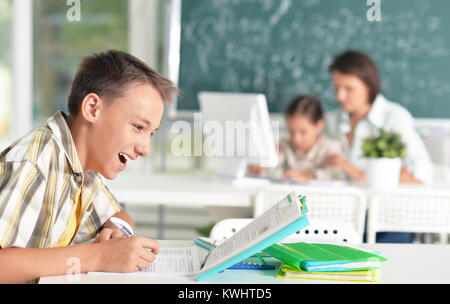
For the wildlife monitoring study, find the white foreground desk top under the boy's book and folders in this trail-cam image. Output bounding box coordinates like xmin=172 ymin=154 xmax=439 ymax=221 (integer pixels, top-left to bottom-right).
xmin=39 ymin=241 xmax=450 ymax=284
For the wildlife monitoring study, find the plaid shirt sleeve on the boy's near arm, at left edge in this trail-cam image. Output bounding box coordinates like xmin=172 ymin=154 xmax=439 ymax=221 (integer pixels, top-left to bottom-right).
xmin=0 ymin=161 xmax=45 ymax=248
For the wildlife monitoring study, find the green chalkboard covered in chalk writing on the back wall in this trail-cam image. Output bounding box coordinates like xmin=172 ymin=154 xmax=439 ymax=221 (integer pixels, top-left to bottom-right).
xmin=177 ymin=0 xmax=450 ymax=118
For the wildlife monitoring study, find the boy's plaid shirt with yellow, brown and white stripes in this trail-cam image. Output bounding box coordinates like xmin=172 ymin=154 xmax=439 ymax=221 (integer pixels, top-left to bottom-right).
xmin=0 ymin=111 xmax=121 ymax=248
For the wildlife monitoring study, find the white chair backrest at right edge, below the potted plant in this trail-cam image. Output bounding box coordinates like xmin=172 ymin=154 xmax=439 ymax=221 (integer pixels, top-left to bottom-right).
xmin=367 ymin=189 xmax=450 ymax=243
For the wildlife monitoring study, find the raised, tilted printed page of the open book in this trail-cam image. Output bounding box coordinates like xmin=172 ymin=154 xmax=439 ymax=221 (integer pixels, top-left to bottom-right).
xmin=201 ymin=192 xmax=302 ymax=272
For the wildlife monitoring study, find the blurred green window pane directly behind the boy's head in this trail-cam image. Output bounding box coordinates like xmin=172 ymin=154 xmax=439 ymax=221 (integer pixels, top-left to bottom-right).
xmin=32 ymin=0 xmax=128 ymax=125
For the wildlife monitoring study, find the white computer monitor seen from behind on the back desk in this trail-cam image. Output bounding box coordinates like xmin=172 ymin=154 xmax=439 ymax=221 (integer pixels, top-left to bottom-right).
xmin=198 ymin=92 xmax=278 ymax=182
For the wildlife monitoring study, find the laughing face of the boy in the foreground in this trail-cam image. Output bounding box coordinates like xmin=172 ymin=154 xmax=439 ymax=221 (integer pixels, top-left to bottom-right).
xmin=86 ymin=83 xmax=164 ymax=179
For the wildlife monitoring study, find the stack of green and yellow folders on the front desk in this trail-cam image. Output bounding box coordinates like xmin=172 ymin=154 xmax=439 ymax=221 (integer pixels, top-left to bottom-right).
xmin=264 ymin=242 xmax=386 ymax=282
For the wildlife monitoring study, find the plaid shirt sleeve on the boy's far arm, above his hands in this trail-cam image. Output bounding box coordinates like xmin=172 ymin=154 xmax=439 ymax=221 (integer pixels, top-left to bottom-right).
xmin=74 ymin=178 xmax=122 ymax=243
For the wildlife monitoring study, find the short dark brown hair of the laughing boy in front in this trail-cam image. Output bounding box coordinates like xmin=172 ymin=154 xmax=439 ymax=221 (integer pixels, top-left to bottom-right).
xmin=67 ymin=50 xmax=178 ymax=116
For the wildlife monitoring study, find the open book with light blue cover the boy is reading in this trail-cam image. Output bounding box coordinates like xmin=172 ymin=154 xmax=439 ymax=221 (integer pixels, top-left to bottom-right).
xmin=89 ymin=191 xmax=309 ymax=281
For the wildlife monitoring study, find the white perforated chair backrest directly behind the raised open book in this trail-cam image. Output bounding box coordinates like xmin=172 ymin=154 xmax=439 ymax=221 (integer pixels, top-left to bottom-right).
xmin=253 ymin=185 xmax=367 ymax=239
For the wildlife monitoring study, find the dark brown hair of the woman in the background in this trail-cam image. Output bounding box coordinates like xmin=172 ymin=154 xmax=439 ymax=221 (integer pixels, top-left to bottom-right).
xmin=329 ymin=50 xmax=381 ymax=104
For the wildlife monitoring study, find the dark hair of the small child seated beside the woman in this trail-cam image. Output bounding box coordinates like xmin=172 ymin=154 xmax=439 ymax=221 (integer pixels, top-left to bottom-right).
xmin=285 ymin=95 xmax=323 ymax=124
